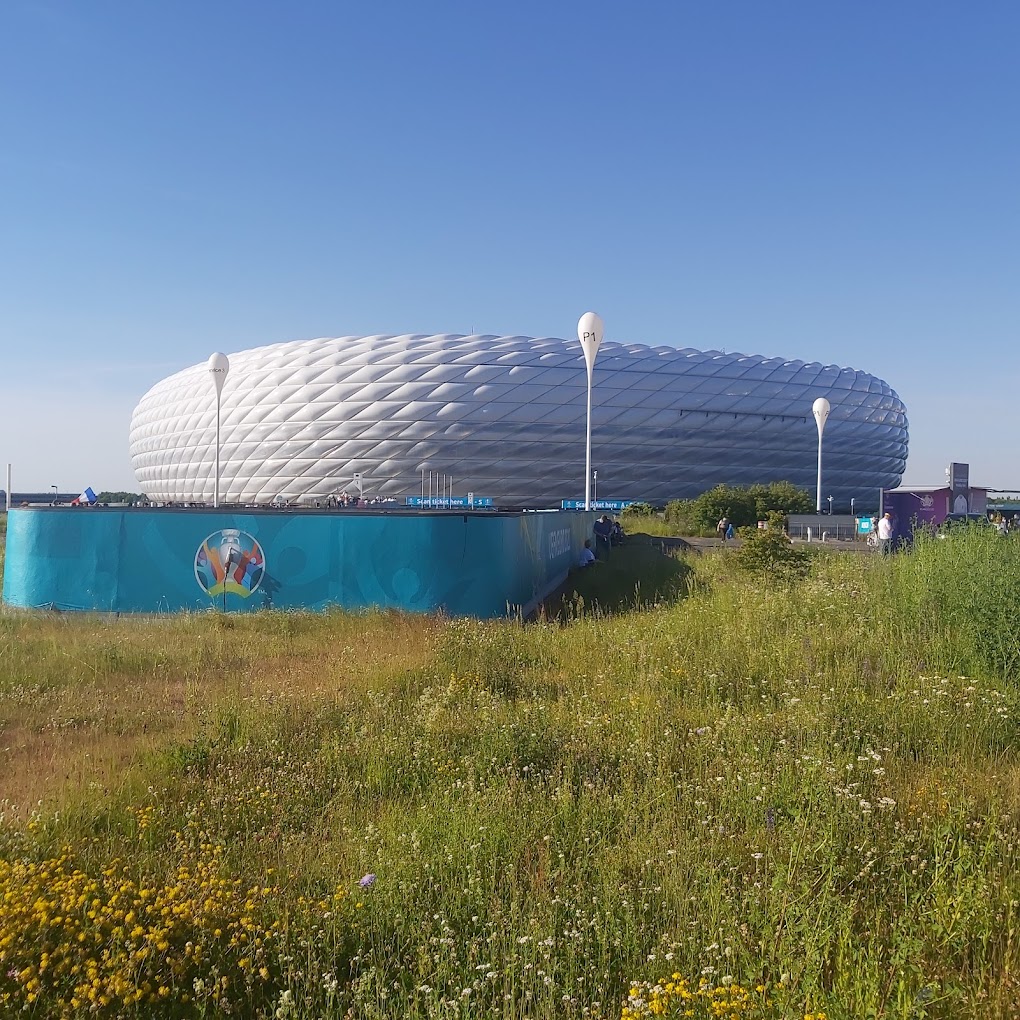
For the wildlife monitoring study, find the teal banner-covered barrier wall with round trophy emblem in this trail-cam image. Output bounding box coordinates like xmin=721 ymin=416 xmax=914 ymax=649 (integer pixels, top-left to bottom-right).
xmin=3 ymin=507 xmax=594 ymax=617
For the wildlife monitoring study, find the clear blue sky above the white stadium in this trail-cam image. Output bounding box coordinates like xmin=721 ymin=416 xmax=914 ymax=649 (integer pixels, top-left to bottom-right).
xmin=0 ymin=0 xmax=1020 ymax=495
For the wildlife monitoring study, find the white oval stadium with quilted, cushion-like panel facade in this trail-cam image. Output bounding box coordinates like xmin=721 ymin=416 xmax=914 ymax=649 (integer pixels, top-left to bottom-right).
xmin=131 ymin=335 xmax=907 ymax=509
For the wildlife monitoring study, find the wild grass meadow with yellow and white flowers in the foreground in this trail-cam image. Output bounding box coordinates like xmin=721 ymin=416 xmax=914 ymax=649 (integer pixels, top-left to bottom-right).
xmin=0 ymin=531 xmax=1020 ymax=1020
